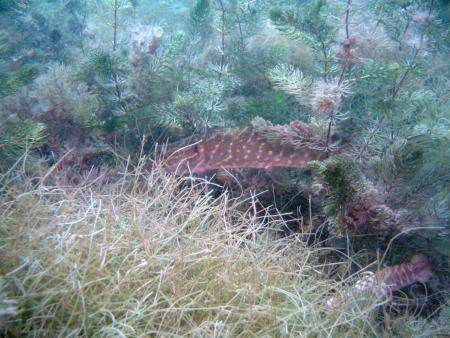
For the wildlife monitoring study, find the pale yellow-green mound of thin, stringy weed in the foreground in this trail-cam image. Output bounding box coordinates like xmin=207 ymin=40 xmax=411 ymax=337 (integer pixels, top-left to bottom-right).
xmin=0 ymin=162 xmax=448 ymax=337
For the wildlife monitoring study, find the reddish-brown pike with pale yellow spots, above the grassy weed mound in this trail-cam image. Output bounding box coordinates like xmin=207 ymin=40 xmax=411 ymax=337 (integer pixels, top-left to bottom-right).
xmin=165 ymin=129 xmax=327 ymax=174
